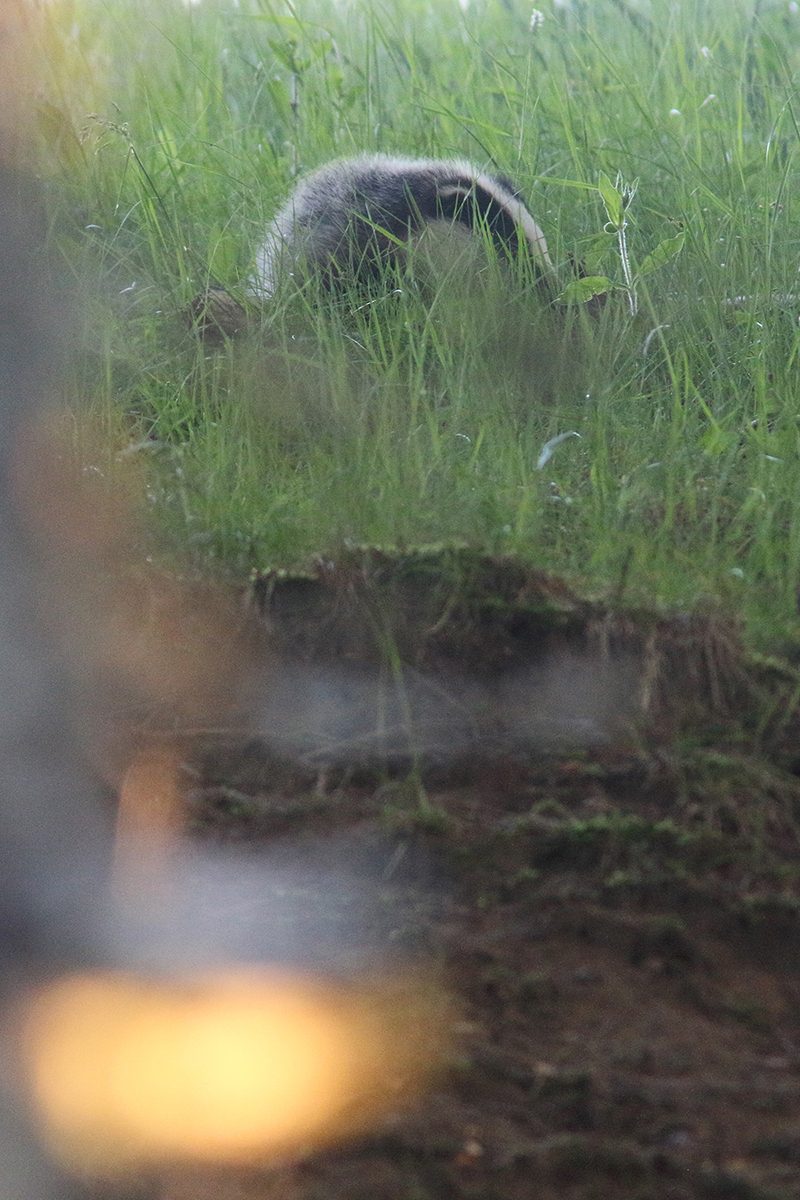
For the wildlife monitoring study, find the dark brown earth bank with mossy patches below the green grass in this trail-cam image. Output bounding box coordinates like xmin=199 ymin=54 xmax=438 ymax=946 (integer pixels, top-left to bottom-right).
xmin=155 ymin=551 xmax=800 ymax=1200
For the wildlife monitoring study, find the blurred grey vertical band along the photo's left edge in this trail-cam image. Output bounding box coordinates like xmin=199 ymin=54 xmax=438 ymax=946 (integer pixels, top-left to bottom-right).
xmin=0 ymin=163 xmax=110 ymax=1200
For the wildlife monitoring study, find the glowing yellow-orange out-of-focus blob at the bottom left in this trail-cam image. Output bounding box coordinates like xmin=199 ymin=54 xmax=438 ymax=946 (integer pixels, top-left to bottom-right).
xmin=22 ymin=972 xmax=444 ymax=1174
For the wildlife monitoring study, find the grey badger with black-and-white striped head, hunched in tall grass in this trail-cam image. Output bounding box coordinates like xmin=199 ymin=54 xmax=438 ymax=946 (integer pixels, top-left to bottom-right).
xmin=253 ymin=155 xmax=553 ymax=296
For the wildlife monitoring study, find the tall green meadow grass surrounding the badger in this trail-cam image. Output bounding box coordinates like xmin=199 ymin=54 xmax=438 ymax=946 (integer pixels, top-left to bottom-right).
xmin=34 ymin=0 xmax=800 ymax=652
